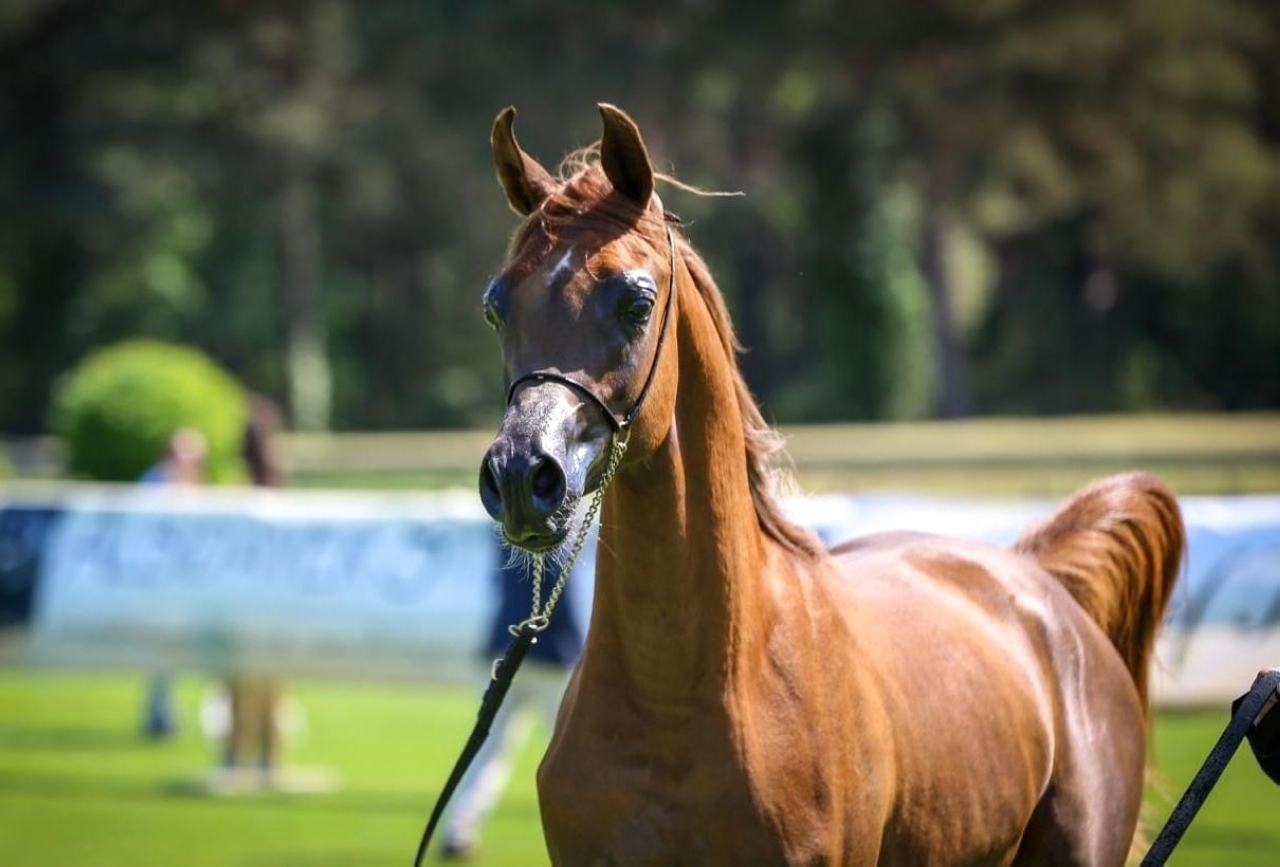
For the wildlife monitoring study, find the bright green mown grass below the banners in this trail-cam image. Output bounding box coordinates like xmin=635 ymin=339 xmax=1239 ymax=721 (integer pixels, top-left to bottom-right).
xmin=0 ymin=671 xmax=1280 ymax=867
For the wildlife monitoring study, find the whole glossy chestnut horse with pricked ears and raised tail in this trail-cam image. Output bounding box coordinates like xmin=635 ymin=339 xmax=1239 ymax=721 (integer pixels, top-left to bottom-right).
xmin=480 ymin=105 xmax=1184 ymax=866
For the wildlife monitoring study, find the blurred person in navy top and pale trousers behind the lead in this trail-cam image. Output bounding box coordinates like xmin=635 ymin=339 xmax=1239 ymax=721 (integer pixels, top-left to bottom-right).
xmin=440 ymin=548 xmax=584 ymax=861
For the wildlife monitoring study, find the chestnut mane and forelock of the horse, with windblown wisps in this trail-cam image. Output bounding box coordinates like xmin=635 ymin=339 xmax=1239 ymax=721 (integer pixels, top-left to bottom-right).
xmin=509 ymin=151 xmax=822 ymax=557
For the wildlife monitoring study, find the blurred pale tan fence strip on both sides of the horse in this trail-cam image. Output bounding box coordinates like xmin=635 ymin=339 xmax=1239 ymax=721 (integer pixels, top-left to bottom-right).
xmin=5 ymin=412 xmax=1280 ymax=496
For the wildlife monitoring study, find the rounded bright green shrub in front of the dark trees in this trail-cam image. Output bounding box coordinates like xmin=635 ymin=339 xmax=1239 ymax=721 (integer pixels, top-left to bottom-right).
xmin=51 ymin=341 xmax=246 ymax=482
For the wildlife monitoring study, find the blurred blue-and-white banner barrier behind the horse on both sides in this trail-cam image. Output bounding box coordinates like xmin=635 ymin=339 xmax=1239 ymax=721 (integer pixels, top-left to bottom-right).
xmin=0 ymin=485 xmax=1280 ymax=706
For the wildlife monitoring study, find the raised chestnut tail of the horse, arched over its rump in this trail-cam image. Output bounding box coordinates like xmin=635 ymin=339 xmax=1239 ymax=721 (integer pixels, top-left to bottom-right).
xmin=1014 ymin=473 xmax=1187 ymax=712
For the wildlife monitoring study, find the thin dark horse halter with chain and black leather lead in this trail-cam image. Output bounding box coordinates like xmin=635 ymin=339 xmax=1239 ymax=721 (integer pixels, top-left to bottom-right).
xmin=413 ymin=213 xmax=676 ymax=867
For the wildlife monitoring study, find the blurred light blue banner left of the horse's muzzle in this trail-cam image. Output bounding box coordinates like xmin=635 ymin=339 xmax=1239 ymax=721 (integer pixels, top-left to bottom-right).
xmin=0 ymin=487 xmax=540 ymax=683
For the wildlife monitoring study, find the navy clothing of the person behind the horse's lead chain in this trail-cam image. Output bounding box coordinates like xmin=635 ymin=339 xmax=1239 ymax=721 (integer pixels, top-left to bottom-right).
xmin=485 ymin=552 xmax=584 ymax=667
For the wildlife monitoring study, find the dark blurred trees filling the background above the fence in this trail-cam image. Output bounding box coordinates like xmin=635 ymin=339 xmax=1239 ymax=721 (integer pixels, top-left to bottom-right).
xmin=0 ymin=0 xmax=1280 ymax=433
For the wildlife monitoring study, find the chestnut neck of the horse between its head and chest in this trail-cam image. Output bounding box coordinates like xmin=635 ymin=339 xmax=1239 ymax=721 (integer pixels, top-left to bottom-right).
xmin=584 ymin=265 xmax=772 ymax=708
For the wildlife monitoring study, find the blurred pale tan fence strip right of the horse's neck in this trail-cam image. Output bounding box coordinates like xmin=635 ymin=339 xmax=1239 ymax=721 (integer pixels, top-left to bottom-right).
xmin=785 ymin=414 xmax=1280 ymax=496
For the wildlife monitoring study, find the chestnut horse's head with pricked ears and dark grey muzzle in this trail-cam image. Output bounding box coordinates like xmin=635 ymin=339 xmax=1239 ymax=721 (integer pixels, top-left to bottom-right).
xmin=480 ymin=104 xmax=676 ymax=552
